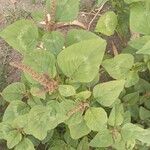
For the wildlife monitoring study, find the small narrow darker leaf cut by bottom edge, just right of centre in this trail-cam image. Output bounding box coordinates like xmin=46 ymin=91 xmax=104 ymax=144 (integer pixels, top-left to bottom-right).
xmin=77 ymin=137 xmax=89 ymax=150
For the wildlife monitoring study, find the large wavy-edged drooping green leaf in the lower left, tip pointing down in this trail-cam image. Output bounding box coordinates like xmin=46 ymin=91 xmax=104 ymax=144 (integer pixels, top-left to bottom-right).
xmin=25 ymin=105 xmax=55 ymax=140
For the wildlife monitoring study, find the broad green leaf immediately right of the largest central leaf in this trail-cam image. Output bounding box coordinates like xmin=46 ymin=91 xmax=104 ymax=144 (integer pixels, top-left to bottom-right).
xmin=102 ymin=54 xmax=134 ymax=79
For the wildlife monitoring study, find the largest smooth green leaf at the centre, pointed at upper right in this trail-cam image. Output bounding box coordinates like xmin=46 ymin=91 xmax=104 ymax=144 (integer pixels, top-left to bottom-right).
xmin=57 ymin=39 xmax=106 ymax=82
